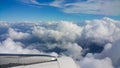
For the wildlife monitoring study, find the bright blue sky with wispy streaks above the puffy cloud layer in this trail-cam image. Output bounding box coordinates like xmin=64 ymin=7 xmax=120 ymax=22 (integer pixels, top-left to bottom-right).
xmin=0 ymin=0 xmax=120 ymax=22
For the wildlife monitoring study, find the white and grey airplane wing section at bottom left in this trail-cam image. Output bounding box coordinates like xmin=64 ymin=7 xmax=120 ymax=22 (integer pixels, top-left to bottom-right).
xmin=0 ymin=54 xmax=76 ymax=68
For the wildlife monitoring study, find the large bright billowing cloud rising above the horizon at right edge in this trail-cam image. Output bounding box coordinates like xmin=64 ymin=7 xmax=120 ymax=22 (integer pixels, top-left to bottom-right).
xmin=82 ymin=17 xmax=120 ymax=43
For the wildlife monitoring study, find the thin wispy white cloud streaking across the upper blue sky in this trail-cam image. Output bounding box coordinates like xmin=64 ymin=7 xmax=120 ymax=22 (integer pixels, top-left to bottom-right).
xmin=21 ymin=0 xmax=120 ymax=15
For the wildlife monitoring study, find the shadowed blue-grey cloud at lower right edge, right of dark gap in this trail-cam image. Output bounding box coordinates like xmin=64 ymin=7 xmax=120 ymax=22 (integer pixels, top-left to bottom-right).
xmin=98 ymin=40 xmax=120 ymax=67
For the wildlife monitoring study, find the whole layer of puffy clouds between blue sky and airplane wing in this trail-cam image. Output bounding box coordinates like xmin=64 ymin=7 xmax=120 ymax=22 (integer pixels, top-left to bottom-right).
xmin=0 ymin=17 xmax=120 ymax=68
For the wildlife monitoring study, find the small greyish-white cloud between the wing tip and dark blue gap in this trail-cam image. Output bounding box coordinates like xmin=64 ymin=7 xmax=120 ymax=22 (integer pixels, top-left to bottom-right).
xmin=59 ymin=42 xmax=82 ymax=59
